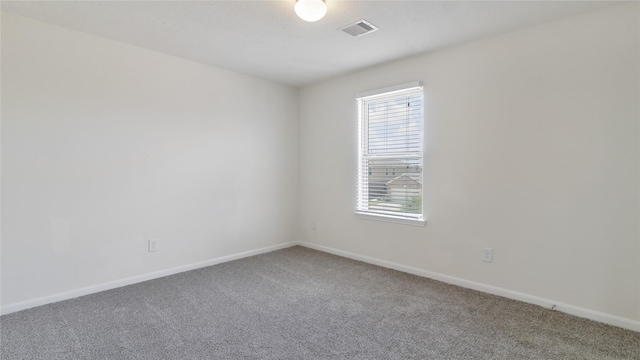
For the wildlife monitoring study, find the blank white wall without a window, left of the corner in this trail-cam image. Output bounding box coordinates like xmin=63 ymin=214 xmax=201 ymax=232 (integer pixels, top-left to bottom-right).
xmin=1 ymin=13 xmax=298 ymax=306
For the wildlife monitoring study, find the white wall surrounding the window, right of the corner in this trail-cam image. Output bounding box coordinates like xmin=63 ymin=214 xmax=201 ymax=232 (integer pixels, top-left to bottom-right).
xmin=299 ymin=3 xmax=640 ymax=321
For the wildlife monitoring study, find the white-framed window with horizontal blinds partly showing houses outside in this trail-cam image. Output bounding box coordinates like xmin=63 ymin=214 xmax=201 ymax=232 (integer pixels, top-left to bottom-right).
xmin=356 ymin=82 xmax=424 ymax=225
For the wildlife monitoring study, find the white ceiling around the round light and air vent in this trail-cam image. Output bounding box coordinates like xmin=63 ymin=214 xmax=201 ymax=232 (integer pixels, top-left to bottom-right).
xmin=1 ymin=0 xmax=613 ymax=86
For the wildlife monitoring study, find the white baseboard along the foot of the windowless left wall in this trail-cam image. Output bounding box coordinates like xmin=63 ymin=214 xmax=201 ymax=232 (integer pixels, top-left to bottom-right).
xmin=0 ymin=242 xmax=297 ymax=315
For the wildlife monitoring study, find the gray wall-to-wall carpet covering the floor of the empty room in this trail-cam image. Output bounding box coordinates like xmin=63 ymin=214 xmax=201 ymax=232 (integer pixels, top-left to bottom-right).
xmin=0 ymin=247 xmax=640 ymax=360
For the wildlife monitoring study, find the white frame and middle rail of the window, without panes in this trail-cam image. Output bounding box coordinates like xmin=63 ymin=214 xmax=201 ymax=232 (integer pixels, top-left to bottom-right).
xmin=355 ymin=81 xmax=426 ymax=226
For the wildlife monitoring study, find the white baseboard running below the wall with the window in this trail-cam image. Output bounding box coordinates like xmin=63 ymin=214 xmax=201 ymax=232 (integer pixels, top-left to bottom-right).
xmin=298 ymin=242 xmax=640 ymax=332
